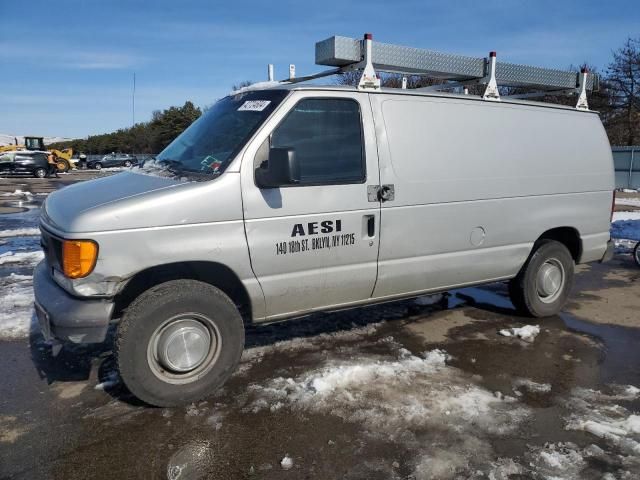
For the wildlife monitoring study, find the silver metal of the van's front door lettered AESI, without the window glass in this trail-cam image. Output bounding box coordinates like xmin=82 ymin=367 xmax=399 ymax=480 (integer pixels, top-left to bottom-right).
xmin=241 ymin=91 xmax=380 ymax=320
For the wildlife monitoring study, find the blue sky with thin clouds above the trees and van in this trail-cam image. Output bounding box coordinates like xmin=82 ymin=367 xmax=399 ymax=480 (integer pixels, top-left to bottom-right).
xmin=0 ymin=0 xmax=640 ymax=137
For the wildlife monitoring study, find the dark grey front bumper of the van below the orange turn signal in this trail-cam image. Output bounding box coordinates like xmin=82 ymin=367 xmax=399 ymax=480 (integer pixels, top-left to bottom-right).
xmin=33 ymin=260 xmax=114 ymax=343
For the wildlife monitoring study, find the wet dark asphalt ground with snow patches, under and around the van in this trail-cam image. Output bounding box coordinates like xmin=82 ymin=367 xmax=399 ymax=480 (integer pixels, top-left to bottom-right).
xmin=0 ymin=173 xmax=640 ymax=480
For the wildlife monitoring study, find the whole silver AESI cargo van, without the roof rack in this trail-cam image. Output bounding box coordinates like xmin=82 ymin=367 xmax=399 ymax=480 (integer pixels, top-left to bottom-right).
xmin=34 ymin=39 xmax=614 ymax=406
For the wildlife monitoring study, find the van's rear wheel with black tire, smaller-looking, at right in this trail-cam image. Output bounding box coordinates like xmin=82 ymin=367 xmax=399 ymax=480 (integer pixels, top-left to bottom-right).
xmin=509 ymin=240 xmax=574 ymax=317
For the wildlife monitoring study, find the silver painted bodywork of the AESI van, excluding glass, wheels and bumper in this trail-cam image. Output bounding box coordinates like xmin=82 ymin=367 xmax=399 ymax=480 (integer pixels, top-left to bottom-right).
xmin=36 ymin=86 xmax=613 ymax=338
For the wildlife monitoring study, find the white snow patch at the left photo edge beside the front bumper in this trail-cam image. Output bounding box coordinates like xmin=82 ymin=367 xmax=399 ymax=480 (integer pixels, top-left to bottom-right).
xmin=0 ymin=274 xmax=33 ymax=340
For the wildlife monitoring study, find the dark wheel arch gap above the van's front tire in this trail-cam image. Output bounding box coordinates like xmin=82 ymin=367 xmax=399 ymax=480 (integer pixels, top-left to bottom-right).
xmin=113 ymin=261 xmax=252 ymax=322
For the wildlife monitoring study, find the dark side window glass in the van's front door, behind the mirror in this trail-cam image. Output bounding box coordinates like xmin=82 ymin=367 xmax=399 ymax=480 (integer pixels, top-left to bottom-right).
xmin=271 ymin=98 xmax=366 ymax=185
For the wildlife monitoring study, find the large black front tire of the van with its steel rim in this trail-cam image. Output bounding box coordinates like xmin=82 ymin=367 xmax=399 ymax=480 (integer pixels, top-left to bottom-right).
xmin=116 ymin=280 xmax=244 ymax=407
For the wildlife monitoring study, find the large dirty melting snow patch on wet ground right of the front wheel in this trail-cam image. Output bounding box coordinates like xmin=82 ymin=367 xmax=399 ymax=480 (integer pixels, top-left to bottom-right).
xmin=244 ymin=348 xmax=529 ymax=478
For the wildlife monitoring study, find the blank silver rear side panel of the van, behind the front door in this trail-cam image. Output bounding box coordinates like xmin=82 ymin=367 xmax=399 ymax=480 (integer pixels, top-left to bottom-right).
xmin=371 ymin=94 xmax=613 ymax=297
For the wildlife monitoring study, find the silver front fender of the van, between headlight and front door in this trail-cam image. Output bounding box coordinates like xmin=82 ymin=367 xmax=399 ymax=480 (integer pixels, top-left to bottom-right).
xmin=41 ymin=172 xmax=264 ymax=316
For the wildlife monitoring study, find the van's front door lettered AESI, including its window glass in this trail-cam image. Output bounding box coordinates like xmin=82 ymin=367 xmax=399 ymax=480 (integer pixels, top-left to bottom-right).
xmin=241 ymin=91 xmax=380 ymax=319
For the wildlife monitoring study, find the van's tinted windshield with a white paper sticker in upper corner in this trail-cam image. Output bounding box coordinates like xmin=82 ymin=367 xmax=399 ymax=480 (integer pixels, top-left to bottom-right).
xmin=148 ymin=90 xmax=288 ymax=180
